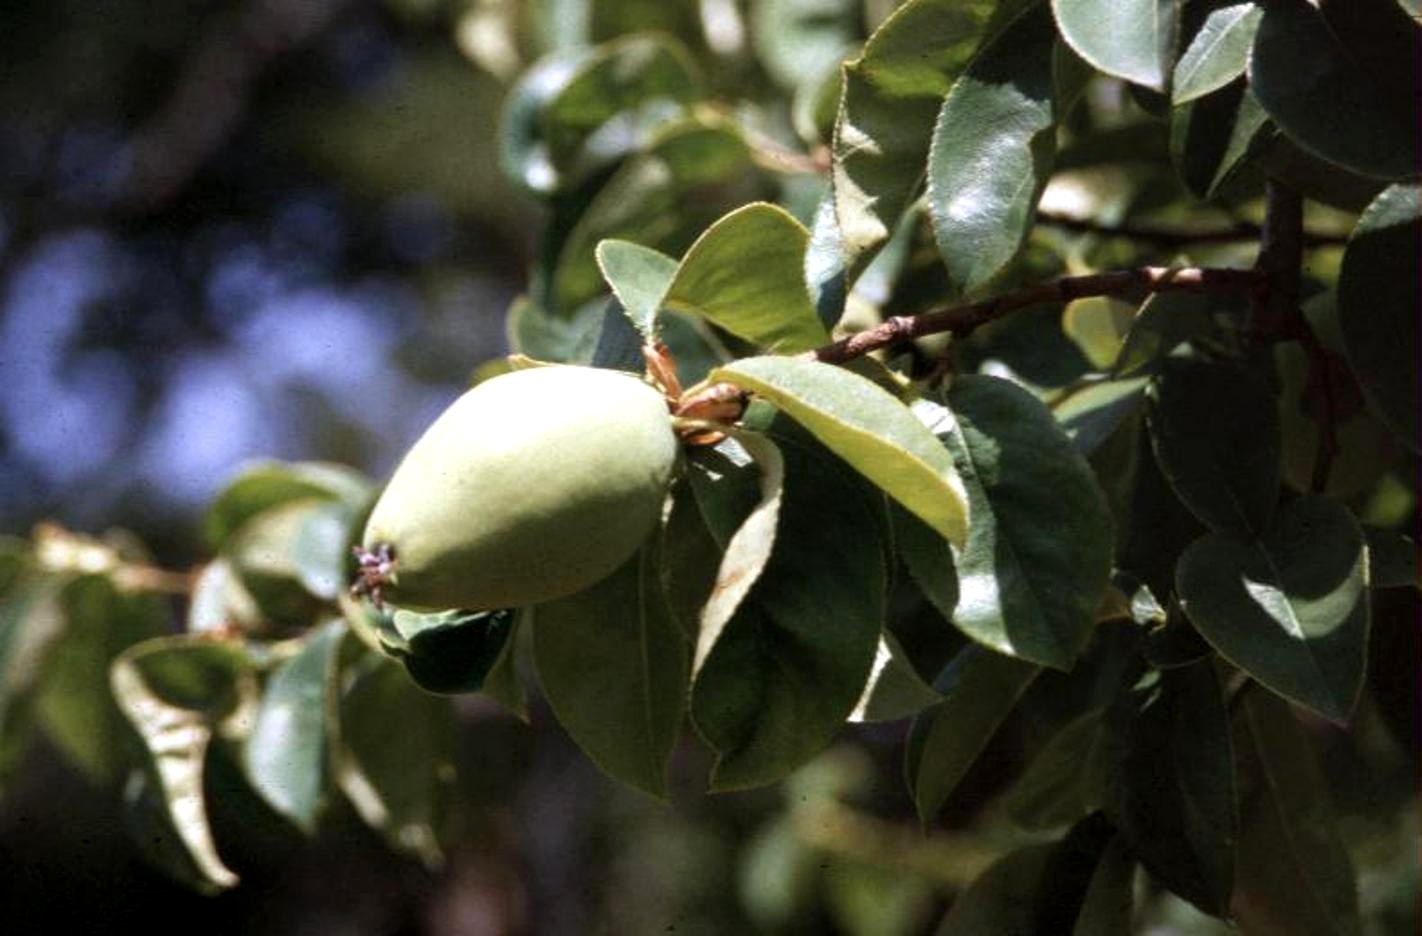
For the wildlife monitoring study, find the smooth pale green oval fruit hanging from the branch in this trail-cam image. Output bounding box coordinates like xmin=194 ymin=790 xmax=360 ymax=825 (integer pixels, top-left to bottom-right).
xmin=364 ymin=366 xmax=678 ymax=610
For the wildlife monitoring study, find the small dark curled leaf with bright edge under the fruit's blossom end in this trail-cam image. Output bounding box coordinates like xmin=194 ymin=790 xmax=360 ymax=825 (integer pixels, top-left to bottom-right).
xmin=392 ymin=609 xmax=513 ymax=694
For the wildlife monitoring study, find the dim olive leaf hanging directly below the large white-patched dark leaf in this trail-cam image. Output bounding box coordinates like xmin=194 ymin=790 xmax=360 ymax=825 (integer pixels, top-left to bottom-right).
xmin=904 ymin=644 xmax=1041 ymax=825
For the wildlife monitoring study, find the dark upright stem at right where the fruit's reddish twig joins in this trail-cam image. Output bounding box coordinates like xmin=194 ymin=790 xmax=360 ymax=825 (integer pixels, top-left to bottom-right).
xmin=1250 ymin=179 xmax=1340 ymax=494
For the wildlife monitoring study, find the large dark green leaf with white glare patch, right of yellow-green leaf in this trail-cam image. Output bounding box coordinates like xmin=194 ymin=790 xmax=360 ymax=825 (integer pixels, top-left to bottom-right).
xmin=939 ymin=376 xmax=1112 ymax=670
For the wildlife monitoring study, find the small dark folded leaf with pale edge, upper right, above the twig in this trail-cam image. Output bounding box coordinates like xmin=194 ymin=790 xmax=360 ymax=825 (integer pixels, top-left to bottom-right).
xmin=1170 ymin=80 xmax=1277 ymax=200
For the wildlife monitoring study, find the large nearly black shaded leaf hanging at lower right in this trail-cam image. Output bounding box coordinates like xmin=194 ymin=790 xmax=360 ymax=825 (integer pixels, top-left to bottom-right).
xmin=1103 ymin=661 xmax=1239 ymax=916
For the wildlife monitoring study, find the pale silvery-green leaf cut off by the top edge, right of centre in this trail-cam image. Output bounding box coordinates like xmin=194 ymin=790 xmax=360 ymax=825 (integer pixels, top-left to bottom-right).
xmin=1052 ymin=0 xmax=1180 ymax=91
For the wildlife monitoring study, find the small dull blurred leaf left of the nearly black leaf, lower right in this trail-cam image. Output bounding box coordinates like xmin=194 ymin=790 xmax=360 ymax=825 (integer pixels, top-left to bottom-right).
xmin=1003 ymin=708 xmax=1106 ymax=831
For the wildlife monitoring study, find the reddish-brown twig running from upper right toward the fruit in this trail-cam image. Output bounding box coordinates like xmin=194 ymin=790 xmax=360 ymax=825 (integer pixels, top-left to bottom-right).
xmin=803 ymin=266 xmax=1267 ymax=364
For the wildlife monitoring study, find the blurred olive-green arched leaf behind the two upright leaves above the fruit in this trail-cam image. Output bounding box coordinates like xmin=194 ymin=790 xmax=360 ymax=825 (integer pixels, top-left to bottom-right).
xmin=548 ymin=118 xmax=757 ymax=310
